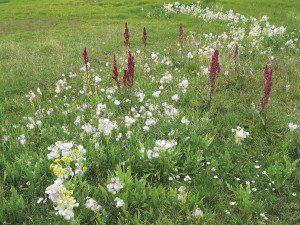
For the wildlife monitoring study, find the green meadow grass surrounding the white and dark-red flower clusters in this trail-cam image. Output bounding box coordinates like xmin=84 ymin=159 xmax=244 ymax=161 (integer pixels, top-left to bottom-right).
xmin=0 ymin=0 xmax=300 ymax=225
